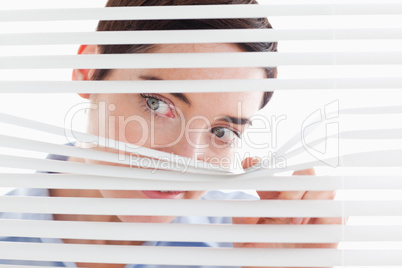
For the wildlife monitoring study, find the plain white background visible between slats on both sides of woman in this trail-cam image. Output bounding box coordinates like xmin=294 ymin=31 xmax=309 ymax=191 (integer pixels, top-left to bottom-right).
xmin=0 ymin=0 xmax=402 ymax=260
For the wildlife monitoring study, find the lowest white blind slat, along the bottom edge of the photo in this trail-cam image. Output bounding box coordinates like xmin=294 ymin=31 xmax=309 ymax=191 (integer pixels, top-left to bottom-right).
xmin=0 ymin=242 xmax=402 ymax=267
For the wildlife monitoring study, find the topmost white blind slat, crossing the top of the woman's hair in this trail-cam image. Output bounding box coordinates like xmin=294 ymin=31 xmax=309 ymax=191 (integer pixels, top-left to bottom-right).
xmin=0 ymin=3 xmax=402 ymax=22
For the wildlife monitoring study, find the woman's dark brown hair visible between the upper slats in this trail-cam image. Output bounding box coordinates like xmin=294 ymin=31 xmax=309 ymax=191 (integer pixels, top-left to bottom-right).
xmin=91 ymin=0 xmax=278 ymax=108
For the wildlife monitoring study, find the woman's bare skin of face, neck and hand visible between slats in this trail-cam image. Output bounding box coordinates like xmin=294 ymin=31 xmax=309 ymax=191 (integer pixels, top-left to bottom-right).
xmin=51 ymin=44 xmax=340 ymax=268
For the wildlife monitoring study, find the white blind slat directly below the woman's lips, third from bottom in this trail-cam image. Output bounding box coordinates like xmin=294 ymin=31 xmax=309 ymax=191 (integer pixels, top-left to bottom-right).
xmin=0 ymin=196 xmax=402 ymax=218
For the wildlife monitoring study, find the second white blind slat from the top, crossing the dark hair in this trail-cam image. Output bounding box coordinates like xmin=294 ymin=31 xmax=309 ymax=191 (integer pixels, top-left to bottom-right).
xmin=0 ymin=28 xmax=402 ymax=46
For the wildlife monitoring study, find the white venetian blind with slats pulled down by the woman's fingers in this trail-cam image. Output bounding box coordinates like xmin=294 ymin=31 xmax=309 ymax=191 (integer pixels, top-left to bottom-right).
xmin=0 ymin=0 xmax=402 ymax=267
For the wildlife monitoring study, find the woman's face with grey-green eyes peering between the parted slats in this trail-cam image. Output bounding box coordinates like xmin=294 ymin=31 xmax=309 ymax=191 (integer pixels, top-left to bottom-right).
xmin=78 ymin=44 xmax=266 ymax=222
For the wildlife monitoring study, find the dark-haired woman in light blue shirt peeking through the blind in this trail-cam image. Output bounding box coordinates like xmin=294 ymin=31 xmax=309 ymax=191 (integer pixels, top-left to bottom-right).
xmin=0 ymin=0 xmax=340 ymax=268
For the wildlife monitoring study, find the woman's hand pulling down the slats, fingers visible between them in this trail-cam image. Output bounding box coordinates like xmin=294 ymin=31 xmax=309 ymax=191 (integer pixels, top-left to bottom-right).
xmin=233 ymin=157 xmax=342 ymax=268
